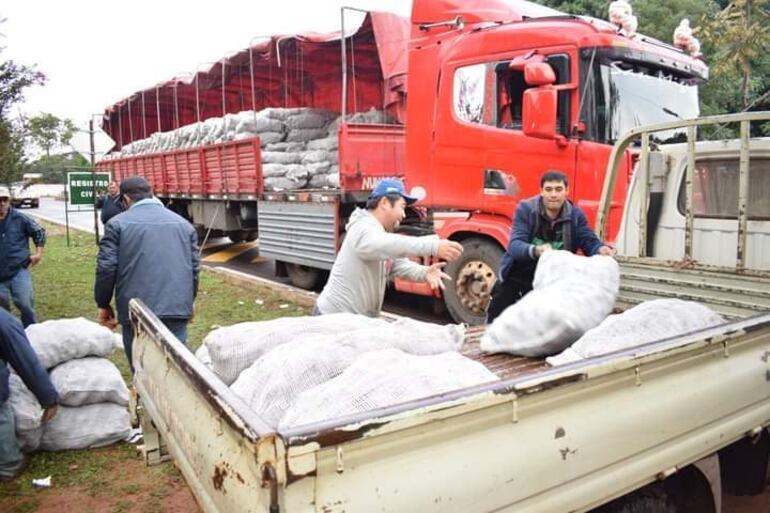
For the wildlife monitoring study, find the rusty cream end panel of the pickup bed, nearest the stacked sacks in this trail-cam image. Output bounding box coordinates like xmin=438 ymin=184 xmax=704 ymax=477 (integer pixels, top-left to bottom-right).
xmin=129 ymin=299 xmax=275 ymax=513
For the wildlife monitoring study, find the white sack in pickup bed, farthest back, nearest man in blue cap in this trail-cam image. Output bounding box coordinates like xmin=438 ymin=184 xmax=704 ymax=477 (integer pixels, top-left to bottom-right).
xmin=203 ymin=313 xmax=386 ymax=385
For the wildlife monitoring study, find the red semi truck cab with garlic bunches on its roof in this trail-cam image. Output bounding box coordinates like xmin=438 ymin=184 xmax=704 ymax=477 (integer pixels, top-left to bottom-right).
xmin=390 ymin=0 xmax=708 ymax=324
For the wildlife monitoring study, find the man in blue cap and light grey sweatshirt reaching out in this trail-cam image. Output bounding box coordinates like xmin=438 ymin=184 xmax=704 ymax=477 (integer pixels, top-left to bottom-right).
xmin=314 ymin=179 xmax=463 ymax=317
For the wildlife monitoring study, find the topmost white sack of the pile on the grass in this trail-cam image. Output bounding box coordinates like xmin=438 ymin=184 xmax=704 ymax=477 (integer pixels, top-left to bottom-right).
xmin=25 ymin=317 xmax=115 ymax=369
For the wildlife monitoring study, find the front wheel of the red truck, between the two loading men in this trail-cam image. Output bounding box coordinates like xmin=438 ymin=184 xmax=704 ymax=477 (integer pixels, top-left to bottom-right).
xmin=444 ymin=237 xmax=503 ymax=326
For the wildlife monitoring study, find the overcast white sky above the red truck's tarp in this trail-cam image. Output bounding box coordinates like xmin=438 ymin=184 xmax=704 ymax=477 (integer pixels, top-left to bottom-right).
xmin=0 ymin=0 xmax=411 ymax=151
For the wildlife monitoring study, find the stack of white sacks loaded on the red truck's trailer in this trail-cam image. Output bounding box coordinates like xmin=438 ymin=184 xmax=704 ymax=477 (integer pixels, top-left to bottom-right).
xmin=97 ymin=107 xmax=389 ymax=191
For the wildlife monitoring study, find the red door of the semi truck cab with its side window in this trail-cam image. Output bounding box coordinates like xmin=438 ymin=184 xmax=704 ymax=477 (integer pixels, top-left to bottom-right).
xmin=431 ymin=47 xmax=576 ymax=217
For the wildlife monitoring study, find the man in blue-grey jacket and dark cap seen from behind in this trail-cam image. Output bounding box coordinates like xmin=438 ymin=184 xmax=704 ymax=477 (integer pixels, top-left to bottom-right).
xmin=94 ymin=176 xmax=200 ymax=372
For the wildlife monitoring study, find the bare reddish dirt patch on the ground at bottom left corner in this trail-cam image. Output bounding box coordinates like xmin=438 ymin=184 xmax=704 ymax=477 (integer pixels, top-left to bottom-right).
xmin=0 ymin=447 xmax=201 ymax=513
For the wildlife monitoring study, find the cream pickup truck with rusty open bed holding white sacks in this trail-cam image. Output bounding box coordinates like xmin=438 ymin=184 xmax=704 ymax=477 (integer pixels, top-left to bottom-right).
xmin=130 ymin=113 xmax=770 ymax=513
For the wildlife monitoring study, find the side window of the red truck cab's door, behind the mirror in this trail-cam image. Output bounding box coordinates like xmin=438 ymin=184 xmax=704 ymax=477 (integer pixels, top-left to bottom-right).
xmin=452 ymin=53 xmax=571 ymax=136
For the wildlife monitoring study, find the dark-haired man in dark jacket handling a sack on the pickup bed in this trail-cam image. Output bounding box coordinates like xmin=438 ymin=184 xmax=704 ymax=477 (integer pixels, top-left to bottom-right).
xmin=487 ymin=171 xmax=615 ymax=323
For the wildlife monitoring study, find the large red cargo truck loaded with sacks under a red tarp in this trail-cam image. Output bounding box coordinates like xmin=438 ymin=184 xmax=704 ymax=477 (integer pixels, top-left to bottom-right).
xmin=97 ymin=0 xmax=708 ymax=324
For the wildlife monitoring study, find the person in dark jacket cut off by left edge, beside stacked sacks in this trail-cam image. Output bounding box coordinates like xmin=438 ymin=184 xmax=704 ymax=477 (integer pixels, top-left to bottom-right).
xmin=0 ymin=298 xmax=59 ymax=481
